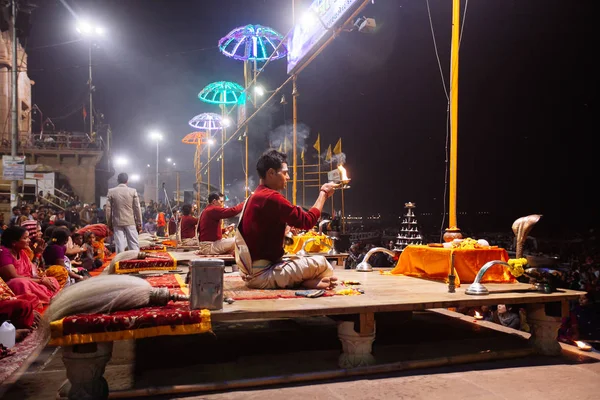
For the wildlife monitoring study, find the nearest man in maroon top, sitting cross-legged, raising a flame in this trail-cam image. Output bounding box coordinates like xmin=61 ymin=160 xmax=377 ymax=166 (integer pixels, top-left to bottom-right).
xmin=235 ymin=150 xmax=337 ymax=289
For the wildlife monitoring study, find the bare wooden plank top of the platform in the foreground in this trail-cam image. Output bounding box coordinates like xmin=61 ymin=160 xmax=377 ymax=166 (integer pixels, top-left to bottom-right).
xmin=211 ymin=270 xmax=584 ymax=321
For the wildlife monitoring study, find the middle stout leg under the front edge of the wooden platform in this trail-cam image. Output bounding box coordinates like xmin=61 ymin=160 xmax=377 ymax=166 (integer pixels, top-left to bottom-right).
xmin=338 ymin=313 xmax=375 ymax=368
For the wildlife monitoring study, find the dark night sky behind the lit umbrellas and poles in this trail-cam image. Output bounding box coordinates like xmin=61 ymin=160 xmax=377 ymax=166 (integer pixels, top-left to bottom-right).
xmin=22 ymin=0 xmax=600 ymax=231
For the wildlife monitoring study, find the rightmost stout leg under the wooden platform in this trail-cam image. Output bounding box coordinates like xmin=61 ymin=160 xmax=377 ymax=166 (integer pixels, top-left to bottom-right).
xmin=527 ymin=303 xmax=561 ymax=356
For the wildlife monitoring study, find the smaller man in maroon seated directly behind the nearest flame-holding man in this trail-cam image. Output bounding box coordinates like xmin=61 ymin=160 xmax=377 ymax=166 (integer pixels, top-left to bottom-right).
xmin=198 ymin=193 xmax=244 ymax=254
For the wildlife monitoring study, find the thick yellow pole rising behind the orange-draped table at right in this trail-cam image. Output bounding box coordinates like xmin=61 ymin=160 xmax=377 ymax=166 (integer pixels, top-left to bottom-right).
xmin=448 ymin=0 xmax=460 ymax=229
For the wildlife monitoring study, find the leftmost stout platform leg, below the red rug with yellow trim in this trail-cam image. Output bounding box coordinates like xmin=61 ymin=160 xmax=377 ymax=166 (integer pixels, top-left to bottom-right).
xmin=58 ymin=342 xmax=113 ymax=400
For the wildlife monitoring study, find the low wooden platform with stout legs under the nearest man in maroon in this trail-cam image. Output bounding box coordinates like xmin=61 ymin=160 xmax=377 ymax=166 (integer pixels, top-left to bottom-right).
xmin=52 ymin=270 xmax=584 ymax=399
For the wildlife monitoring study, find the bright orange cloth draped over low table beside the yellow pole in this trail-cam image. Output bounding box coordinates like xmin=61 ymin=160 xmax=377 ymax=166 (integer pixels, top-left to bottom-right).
xmin=391 ymin=246 xmax=516 ymax=286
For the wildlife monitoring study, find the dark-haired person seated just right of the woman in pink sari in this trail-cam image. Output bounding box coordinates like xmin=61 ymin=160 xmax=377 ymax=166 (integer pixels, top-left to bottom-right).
xmin=43 ymin=227 xmax=85 ymax=288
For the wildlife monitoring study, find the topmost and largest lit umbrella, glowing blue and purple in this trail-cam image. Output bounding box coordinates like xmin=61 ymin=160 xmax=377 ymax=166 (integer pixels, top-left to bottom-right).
xmin=219 ymin=25 xmax=287 ymax=62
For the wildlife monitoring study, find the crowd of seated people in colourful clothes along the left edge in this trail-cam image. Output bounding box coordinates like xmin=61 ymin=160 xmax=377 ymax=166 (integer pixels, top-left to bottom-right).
xmin=0 ymin=203 xmax=110 ymax=350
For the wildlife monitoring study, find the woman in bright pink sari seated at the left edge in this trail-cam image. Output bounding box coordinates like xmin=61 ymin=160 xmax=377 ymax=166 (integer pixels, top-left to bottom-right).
xmin=0 ymin=226 xmax=60 ymax=304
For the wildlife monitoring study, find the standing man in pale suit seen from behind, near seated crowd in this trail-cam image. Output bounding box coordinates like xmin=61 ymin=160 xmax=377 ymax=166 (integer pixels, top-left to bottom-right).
xmin=106 ymin=172 xmax=142 ymax=254
